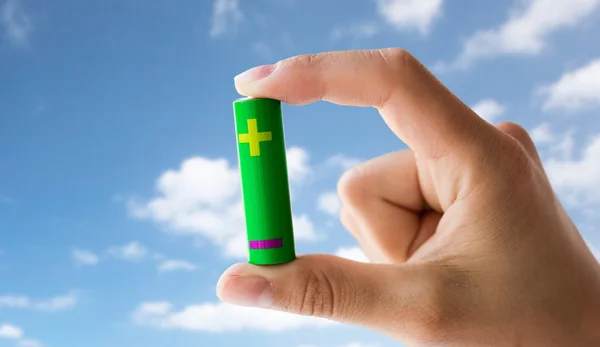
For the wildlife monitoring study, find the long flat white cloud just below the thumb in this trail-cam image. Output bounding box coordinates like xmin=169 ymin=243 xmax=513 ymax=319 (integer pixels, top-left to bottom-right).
xmin=132 ymin=302 xmax=335 ymax=333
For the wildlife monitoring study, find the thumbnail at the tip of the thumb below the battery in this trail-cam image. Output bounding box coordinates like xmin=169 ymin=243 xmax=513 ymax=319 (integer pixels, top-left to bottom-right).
xmin=221 ymin=276 xmax=273 ymax=308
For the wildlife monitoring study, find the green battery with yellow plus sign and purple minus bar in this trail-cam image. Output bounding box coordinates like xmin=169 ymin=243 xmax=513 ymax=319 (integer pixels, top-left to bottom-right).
xmin=233 ymin=98 xmax=296 ymax=265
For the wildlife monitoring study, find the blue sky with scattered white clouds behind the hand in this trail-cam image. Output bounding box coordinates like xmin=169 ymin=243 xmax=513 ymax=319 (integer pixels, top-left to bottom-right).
xmin=0 ymin=0 xmax=600 ymax=347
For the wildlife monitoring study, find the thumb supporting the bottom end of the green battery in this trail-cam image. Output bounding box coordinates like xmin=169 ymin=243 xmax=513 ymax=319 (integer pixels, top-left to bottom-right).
xmin=217 ymin=255 xmax=430 ymax=331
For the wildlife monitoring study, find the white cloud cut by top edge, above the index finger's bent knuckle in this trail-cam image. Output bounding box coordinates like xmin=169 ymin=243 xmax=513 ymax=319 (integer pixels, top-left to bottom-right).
xmin=377 ymin=0 xmax=444 ymax=34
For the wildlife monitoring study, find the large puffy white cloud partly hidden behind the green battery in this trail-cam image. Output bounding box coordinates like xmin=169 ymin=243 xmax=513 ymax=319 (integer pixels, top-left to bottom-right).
xmin=129 ymin=147 xmax=315 ymax=258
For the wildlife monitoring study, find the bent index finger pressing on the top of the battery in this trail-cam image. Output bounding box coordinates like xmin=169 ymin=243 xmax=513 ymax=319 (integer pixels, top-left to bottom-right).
xmin=235 ymin=49 xmax=499 ymax=158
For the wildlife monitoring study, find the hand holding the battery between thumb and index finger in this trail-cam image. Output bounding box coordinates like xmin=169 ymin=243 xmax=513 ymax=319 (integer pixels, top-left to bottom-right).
xmin=217 ymin=49 xmax=600 ymax=347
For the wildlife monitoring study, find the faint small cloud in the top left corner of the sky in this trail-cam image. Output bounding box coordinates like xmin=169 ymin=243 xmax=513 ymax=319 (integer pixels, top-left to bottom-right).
xmin=0 ymin=0 xmax=33 ymax=46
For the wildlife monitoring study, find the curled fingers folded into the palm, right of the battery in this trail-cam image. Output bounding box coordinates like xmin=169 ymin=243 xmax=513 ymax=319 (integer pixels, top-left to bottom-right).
xmin=338 ymin=150 xmax=438 ymax=263
